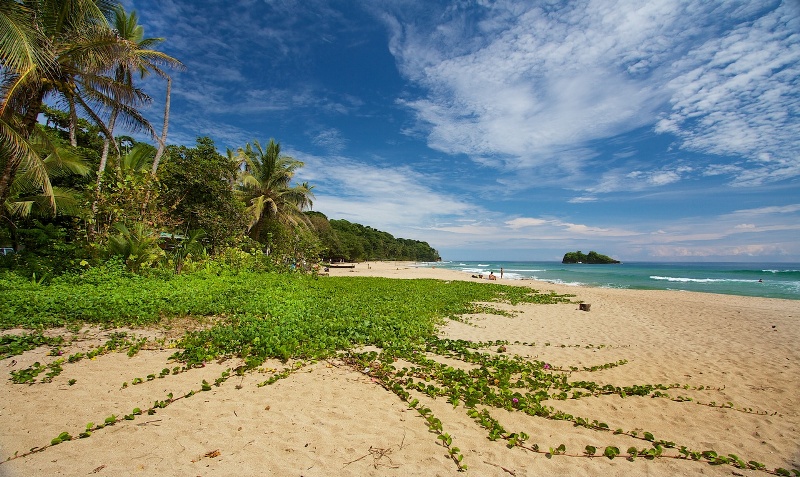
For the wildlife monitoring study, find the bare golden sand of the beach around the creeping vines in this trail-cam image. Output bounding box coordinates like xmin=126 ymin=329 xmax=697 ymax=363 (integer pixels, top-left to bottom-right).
xmin=0 ymin=262 xmax=800 ymax=477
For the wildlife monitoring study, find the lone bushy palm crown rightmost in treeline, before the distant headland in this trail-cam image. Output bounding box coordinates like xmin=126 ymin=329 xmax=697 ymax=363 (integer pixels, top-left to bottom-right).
xmin=239 ymin=139 xmax=314 ymax=240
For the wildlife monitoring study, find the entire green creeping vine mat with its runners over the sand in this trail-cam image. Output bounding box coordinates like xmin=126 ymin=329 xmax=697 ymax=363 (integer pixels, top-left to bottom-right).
xmin=0 ymin=272 xmax=800 ymax=475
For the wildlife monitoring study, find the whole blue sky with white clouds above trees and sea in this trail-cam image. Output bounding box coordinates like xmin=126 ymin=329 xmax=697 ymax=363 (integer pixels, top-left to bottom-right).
xmin=123 ymin=0 xmax=800 ymax=262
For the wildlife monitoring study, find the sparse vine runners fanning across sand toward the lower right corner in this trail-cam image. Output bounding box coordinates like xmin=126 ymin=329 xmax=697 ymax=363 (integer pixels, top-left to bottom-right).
xmin=343 ymin=338 xmax=800 ymax=476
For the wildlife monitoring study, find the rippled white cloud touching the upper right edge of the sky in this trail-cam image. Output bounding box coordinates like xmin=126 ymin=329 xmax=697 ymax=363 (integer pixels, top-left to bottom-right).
xmin=656 ymin=2 xmax=800 ymax=186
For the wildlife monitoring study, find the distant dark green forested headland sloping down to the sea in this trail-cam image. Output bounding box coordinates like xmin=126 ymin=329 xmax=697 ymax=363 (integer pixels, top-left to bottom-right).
xmin=307 ymin=212 xmax=441 ymax=262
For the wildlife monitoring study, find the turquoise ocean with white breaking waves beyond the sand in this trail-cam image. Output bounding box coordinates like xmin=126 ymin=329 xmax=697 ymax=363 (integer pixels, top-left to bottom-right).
xmin=417 ymin=261 xmax=800 ymax=300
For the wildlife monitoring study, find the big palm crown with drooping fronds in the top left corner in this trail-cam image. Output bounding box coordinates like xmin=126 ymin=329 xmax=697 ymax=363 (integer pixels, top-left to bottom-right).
xmin=0 ymin=0 xmax=152 ymax=212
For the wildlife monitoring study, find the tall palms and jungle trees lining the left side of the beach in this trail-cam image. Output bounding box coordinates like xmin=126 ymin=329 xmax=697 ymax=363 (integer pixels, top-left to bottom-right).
xmin=0 ymin=0 xmax=438 ymax=280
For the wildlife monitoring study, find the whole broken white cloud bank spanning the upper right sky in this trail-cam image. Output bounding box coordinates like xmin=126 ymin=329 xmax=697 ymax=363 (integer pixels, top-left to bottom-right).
xmin=382 ymin=0 xmax=800 ymax=193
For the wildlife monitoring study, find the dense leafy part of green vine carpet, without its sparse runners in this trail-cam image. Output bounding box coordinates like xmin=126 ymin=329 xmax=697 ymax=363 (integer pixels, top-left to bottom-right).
xmin=0 ymin=267 xmax=559 ymax=363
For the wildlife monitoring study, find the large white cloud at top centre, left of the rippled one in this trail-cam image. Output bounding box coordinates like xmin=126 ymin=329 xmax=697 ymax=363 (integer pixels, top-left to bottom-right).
xmin=392 ymin=2 xmax=668 ymax=168
